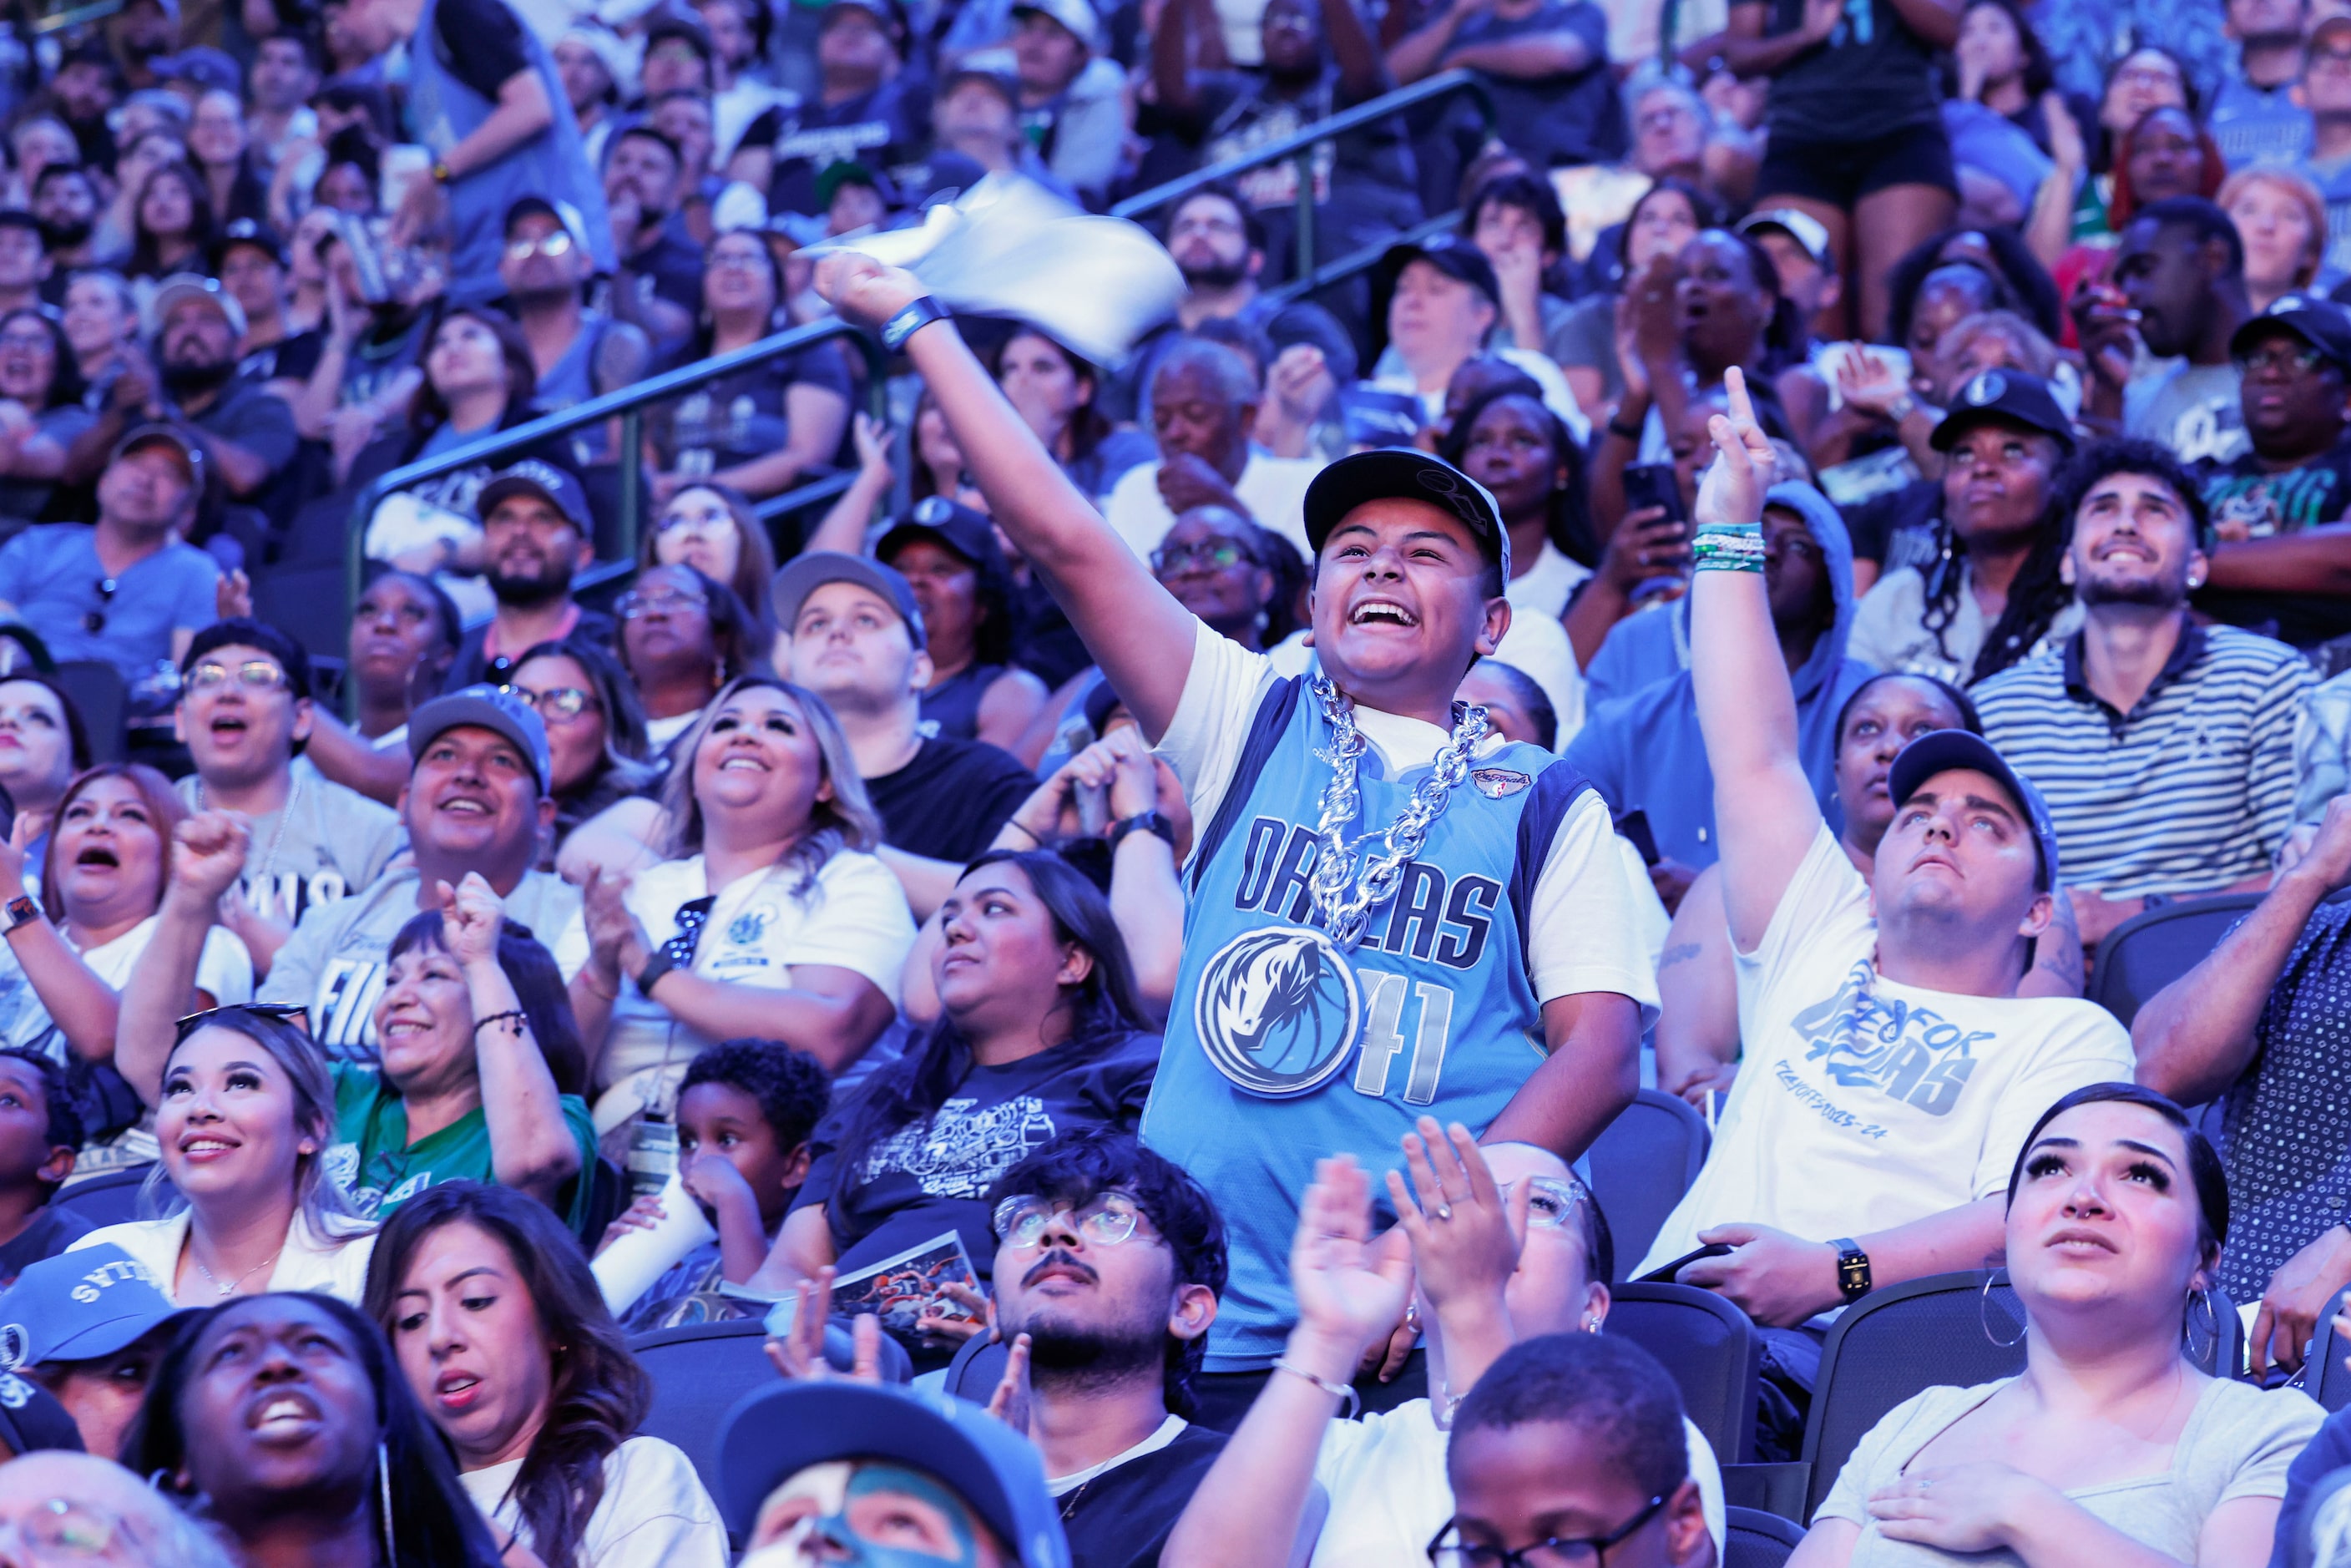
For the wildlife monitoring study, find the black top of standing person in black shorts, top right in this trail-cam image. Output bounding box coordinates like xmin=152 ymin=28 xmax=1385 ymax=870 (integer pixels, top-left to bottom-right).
xmin=1739 ymin=0 xmax=1942 ymax=146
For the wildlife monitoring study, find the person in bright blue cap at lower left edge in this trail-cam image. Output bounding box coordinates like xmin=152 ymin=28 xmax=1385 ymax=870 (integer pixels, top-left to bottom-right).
xmin=0 ymin=1246 xmax=181 ymax=1459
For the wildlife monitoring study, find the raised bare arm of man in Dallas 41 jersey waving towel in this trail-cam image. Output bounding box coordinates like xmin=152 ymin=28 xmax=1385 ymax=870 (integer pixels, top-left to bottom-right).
xmin=816 ymin=254 xmax=1196 ymax=746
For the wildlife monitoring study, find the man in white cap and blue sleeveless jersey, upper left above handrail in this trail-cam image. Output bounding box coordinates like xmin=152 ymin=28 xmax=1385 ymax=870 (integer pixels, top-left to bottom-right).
xmin=498 ymin=195 xmax=654 ymax=468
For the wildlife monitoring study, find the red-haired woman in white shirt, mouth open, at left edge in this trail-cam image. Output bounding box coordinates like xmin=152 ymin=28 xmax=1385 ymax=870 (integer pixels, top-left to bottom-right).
xmin=0 ymin=761 xmax=254 ymax=1159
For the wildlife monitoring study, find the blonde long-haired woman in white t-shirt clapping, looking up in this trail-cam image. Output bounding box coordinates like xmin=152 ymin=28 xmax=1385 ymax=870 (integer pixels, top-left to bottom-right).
xmin=557 ymin=677 xmax=914 ymax=1133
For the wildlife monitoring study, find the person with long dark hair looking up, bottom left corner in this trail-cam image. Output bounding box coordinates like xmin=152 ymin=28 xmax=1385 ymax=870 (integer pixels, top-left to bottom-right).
xmin=122 ymin=1291 xmax=505 ymax=1568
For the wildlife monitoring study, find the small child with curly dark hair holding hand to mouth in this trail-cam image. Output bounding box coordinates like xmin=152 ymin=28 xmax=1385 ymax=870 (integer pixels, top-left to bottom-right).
xmin=597 ymin=1039 xmax=832 ymax=1333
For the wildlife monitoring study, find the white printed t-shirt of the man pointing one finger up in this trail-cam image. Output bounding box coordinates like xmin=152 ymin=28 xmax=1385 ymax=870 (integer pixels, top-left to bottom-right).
xmin=1627 ymin=825 xmax=2135 ymax=1279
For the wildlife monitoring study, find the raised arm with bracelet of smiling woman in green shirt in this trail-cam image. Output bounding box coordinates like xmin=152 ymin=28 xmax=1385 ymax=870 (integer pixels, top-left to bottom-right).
xmin=442 ymin=873 xmax=581 ymax=1206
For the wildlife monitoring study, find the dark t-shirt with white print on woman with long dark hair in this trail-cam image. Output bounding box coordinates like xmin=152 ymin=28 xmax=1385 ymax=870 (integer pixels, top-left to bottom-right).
xmin=792 ymin=1034 xmax=1159 ymax=1279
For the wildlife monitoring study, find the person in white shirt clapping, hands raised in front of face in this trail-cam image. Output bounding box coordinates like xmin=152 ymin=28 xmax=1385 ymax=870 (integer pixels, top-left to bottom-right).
xmin=1161 ymin=1116 xmax=1726 ymax=1568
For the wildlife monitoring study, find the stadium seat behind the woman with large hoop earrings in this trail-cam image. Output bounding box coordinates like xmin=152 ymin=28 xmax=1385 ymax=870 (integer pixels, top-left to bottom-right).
xmin=1803 ymin=1272 xmax=2245 ymax=1519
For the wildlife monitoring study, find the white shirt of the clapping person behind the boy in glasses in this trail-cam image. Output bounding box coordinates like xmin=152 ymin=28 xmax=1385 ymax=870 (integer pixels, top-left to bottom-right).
xmin=1312 ymin=1399 xmax=1723 ymax=1568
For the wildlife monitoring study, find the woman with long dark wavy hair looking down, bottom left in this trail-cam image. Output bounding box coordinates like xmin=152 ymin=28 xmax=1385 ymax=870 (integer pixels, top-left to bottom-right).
xmin=367 ymin=1182 xmax=726 ymax=1568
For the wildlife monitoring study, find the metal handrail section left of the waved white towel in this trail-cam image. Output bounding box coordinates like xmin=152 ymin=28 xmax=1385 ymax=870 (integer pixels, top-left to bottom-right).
xmin=343 ymin=317 xmax=888 ymax=658
